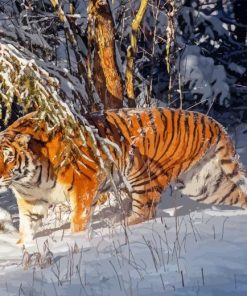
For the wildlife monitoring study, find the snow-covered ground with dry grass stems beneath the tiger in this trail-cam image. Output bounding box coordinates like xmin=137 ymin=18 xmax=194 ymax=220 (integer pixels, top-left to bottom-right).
xmin=0 ymin=125 xmax=247 ymax=296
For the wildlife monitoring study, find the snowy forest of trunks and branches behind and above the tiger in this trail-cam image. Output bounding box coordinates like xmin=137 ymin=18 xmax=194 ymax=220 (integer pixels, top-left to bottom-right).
xmin=0 ymin=0 xmax=247 ymax=125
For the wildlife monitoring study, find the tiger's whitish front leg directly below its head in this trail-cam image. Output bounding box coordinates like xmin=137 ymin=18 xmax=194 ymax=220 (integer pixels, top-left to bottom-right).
xmin=17 ymin=196 xmax=48 ymax=244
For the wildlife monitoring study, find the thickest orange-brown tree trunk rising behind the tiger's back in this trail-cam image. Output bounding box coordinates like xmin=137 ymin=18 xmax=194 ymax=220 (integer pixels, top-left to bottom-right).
xmin=88 ymin=0 xmax=123 ymax=109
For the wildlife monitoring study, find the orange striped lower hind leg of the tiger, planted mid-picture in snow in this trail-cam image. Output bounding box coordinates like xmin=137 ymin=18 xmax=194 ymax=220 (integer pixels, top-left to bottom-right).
xmin=127 ymin=191 xmax=160 ymax=225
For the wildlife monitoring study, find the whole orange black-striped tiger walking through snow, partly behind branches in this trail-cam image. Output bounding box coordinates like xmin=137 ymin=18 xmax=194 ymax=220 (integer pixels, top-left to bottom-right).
xmin=0 ymin=108 xmax=247 ymax=243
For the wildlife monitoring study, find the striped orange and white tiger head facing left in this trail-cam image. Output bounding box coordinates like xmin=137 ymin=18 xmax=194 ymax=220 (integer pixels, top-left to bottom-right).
xmin=0 ymin=132 xmax=34 ymax=191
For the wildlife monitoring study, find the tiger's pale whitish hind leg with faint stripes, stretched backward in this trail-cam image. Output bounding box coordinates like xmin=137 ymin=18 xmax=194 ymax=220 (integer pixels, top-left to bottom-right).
xmin=175 ymin=148 xmax=247 ymax=208
